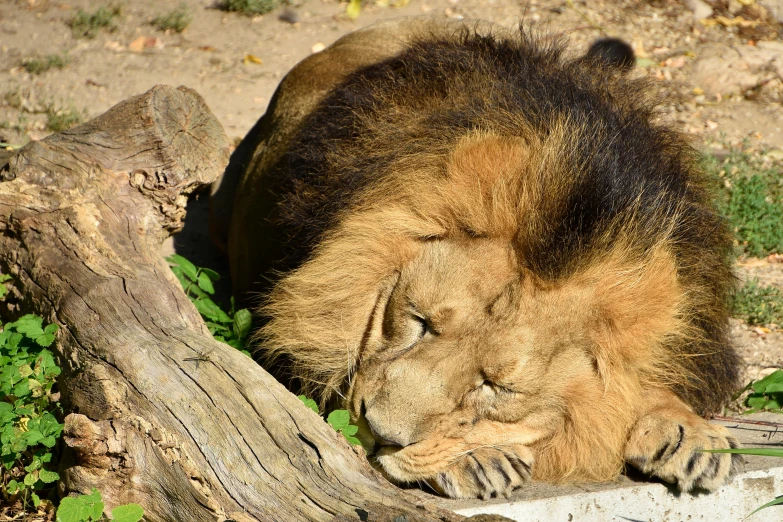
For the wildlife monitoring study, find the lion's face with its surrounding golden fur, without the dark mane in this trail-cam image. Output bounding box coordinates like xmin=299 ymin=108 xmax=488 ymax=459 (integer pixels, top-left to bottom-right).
xmin=262 ymin=134 xmax=682 ymax=496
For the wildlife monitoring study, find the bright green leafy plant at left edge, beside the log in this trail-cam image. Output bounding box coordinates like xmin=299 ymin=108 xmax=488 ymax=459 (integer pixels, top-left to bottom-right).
xmin=0 ymin=315 xmax=63 ymax=507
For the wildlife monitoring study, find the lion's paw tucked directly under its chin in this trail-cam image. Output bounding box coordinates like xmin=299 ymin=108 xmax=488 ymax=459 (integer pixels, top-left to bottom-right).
xmin=431 ymin=445 xmax=534 ymax=500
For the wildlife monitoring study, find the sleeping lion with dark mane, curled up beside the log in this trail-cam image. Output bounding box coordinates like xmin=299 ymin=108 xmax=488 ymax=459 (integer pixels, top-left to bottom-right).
xmin=213 ymin=18 xmax=739 ymax=498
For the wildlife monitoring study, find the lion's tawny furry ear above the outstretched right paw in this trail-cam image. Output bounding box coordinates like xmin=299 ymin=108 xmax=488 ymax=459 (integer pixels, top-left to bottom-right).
xmin=585 ymin=248 xmax=683 ymax=378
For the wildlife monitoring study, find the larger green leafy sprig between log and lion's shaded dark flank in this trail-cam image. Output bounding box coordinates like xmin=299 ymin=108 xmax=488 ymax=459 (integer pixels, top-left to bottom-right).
xmin=166 ymin=254 xmax=252 ymax=356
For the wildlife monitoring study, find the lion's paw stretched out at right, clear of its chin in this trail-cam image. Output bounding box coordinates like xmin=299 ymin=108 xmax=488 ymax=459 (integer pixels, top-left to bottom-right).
xmin=625 ymin=413 xmax=743 ymax=491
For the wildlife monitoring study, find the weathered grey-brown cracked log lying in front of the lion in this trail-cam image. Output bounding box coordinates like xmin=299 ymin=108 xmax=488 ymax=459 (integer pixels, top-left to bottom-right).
xmin=0 ymin=86 xmax=462 ymax=522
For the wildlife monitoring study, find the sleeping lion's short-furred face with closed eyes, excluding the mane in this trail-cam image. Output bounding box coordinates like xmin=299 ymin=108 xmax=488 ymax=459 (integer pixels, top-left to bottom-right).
xmin=348 ymin=237 xmax=601 ymax=482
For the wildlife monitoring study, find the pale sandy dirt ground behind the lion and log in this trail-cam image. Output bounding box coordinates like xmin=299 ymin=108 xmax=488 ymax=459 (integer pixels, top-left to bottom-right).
xmin=0 ymin=0 xmax=783 ymax=379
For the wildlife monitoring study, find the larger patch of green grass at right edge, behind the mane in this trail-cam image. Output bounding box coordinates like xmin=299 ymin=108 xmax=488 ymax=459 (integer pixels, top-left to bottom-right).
xmin=704 ymin=151 xmax=783 ymax=257
